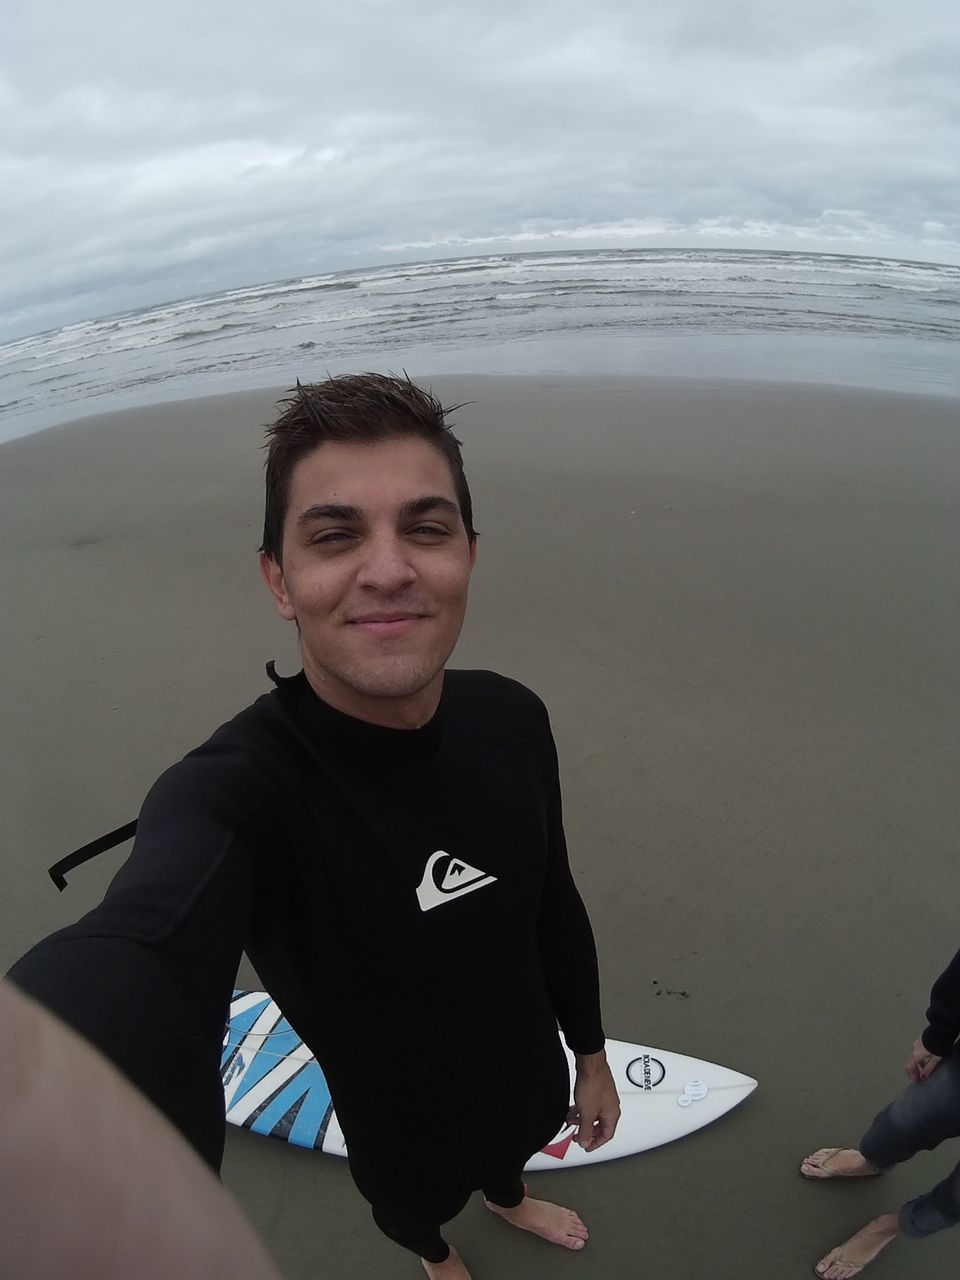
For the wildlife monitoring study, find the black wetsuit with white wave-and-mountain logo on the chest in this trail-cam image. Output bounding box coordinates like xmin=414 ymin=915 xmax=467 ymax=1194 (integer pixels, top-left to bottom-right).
xmin=12 ymin=671 xmax=604 ymax=1249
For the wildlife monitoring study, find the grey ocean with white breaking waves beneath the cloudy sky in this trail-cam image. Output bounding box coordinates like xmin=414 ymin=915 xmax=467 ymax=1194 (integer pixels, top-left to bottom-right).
xmin=0 ymin=250 xmax=960 ymax=440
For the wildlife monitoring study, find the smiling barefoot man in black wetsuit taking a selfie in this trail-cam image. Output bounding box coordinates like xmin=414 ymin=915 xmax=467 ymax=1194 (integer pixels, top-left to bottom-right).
xmin=13 ymin=375 xmax=620 ymax=1280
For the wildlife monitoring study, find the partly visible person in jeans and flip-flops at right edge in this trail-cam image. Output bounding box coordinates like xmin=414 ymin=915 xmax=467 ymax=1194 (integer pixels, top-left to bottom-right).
xmin=800 ymin=951 xmax=960 ymax=1280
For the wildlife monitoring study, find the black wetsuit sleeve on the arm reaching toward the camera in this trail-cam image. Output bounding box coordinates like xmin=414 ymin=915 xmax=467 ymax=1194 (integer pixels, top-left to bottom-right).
xmin=10 ymin=759 xmax=259 ymax=1169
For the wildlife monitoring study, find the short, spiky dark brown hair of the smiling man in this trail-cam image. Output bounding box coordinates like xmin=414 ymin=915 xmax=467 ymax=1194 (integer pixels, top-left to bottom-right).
xmin=260 ymin=374 xmax=476 ymax=564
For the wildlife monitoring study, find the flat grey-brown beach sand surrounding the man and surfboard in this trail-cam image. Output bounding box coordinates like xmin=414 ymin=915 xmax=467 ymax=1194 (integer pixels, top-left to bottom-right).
xmin=0 ymin=376 xmax=960 ymax=1280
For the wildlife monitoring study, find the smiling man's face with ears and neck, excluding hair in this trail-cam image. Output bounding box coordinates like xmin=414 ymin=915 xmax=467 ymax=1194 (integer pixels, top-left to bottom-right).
xmin=260 ymin=438 xmax=476 ymax=727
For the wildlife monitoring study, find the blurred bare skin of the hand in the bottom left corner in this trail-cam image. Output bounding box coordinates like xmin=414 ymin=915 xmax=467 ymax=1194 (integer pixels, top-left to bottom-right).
xmin=0 ymin=982 xmax=285 ymax=1280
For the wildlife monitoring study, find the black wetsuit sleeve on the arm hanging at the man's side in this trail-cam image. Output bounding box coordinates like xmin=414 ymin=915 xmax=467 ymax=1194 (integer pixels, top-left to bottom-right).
xmin=538 ymin=713 xmax=604 ymax=1053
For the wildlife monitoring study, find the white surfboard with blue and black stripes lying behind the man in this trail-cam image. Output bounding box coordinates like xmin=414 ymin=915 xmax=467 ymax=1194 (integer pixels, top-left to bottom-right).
xmin=220 ymin=991 xmax=756 ymax=1170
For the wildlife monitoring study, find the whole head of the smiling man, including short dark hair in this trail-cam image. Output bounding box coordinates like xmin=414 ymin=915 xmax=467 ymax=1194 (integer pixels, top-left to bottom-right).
xmin=260 ymin=375 xmax=476 ymax=727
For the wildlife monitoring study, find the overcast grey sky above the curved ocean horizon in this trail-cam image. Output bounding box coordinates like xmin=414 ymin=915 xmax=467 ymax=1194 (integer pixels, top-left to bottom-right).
xmin=0 ymin=0 xmax=960 ymax=337
